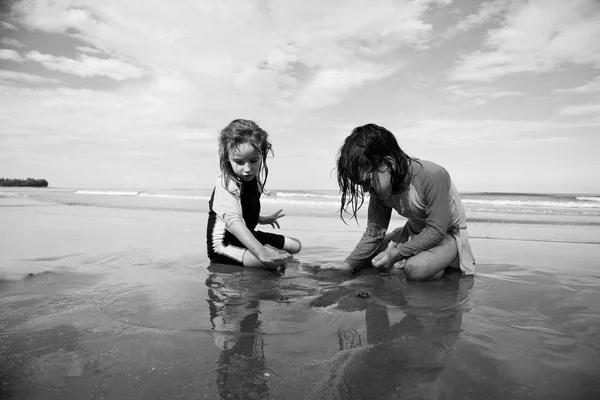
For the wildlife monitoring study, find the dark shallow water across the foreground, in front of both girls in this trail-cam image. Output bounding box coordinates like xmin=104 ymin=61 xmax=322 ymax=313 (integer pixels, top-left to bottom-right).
xmin=0 ymin=254 xmax=600 ymax=399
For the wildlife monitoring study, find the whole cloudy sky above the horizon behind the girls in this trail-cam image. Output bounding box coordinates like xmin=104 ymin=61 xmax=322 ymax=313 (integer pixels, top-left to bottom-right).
xmin=0 ymin=0 xmax=600 ymax=193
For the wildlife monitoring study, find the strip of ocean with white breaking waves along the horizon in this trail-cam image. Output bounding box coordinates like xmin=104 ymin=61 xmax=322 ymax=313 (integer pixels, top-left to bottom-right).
xmin=5 ymin=188 xmax=600 ymax=243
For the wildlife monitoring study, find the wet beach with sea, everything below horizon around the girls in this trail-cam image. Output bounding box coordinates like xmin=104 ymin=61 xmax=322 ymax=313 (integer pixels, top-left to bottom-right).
xmin=0 ymin=188 xmax=600 ymax=399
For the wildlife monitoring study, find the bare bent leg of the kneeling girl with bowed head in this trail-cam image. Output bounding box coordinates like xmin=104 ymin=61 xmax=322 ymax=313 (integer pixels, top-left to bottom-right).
xmin=404 ymin=234 xmax=458 ymax=281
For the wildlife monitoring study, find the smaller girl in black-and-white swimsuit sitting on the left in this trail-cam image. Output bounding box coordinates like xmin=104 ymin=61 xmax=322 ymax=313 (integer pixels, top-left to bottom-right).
xmin=206 ymin=119 xmax=302 ymax=269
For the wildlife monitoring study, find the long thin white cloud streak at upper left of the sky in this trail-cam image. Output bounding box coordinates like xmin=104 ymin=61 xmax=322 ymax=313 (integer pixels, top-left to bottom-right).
xmin=26 ymin=51 xmax=144 ymax=81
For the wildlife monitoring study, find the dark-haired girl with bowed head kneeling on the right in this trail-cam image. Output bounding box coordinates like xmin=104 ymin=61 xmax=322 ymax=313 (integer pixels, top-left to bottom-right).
xmin=323 ymin=124 xmax=475 ymax=280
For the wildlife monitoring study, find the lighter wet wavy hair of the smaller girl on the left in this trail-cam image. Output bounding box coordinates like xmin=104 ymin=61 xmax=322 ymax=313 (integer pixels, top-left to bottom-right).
xmin=219 ymin=119 xmax=273 ymax=193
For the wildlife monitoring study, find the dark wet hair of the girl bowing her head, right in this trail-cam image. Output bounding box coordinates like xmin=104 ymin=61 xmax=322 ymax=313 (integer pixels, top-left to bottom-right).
xmin=337 ymin=124 xmax=418 ymax=223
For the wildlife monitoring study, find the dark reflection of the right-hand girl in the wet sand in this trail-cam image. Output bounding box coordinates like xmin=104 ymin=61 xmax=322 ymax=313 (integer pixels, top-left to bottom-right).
xmin=315 ymin=272 xmax=473 ymax=399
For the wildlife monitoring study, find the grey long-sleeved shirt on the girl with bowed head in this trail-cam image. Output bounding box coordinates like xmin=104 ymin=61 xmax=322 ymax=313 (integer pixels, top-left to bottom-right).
xmin=346 ymin=160 xmax=467 ymax=269
